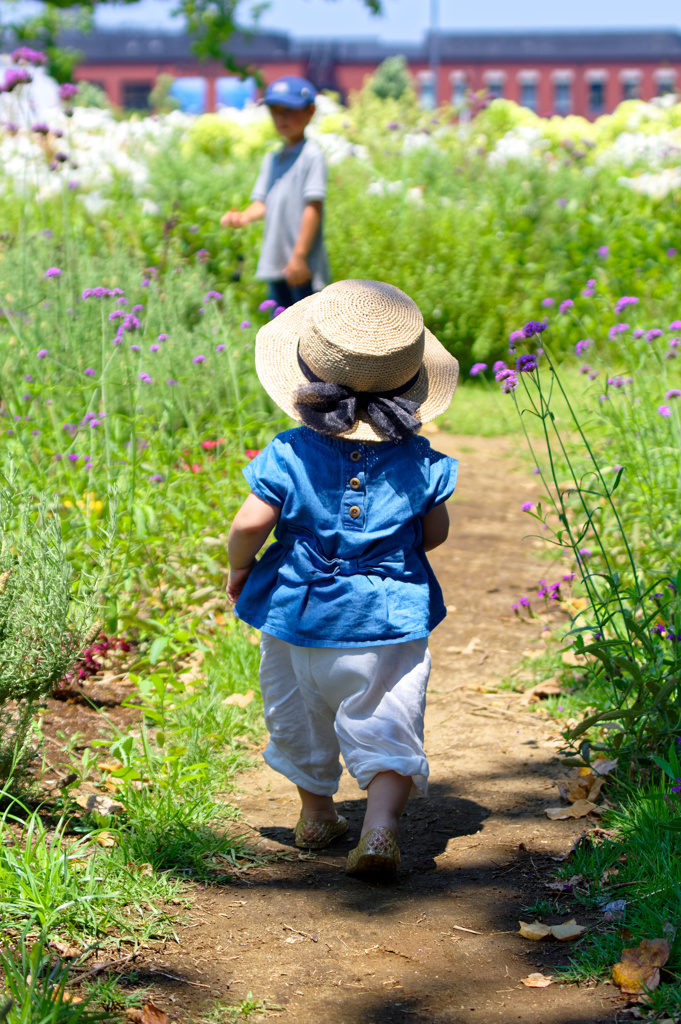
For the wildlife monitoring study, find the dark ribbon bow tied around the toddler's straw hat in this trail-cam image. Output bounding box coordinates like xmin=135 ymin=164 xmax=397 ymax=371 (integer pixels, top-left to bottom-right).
xmin=295 ymin=352 xmax=421 ymax=443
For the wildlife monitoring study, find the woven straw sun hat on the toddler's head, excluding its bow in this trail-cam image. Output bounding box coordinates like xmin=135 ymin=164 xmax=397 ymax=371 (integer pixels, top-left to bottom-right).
xmin=255 ymin=281 xmax=459 ymax=441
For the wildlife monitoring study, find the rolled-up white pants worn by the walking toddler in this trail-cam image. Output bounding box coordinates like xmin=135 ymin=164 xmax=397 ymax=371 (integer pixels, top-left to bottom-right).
xmin=260 ymin=633 xmax=430 ymax=797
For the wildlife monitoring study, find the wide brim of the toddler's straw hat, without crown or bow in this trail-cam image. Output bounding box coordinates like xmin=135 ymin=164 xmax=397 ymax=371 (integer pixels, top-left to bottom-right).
xmin=255 ymin=295 xmax=459 ymax=441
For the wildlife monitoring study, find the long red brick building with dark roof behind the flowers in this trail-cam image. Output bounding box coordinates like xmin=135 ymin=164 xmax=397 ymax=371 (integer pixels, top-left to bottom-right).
xmin=57 ymin=32 xmax=681 ymax=118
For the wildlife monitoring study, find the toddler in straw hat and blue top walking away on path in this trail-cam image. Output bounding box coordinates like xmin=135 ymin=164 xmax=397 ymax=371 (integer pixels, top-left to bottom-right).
xmin=227 ymin=281 xmax=459 ymax=880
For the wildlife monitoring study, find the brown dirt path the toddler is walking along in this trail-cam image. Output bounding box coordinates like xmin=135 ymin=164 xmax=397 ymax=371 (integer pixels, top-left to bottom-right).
xmin=141 ymin=434 xmax=614 ymax=1024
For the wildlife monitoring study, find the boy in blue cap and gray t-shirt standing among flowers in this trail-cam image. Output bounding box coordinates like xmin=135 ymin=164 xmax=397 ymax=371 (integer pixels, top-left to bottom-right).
xmin=220 ymin=75 xmax=330 ymax=308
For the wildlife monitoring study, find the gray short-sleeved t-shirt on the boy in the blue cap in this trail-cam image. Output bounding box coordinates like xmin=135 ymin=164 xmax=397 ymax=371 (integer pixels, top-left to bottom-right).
xmin=251 ymin=139 xmax=331 ymax=292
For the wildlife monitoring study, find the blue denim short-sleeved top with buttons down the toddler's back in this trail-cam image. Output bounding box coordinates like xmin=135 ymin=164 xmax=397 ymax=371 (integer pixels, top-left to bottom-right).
xmin=236 ymin=427 xmax=458 ymax=647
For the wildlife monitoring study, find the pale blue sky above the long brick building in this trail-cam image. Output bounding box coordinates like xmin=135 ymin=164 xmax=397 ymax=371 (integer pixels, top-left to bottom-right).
xmin=97 ymin=0 xmax=681 ymax=41
